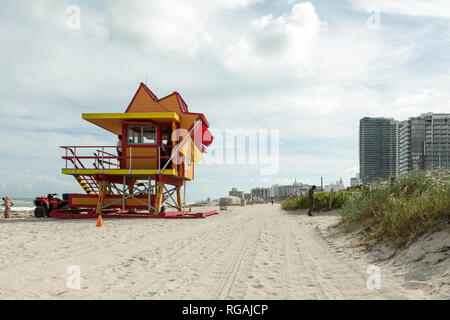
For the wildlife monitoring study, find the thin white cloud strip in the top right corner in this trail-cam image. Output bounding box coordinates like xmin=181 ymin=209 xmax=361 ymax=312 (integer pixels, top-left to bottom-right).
xmin=353 ymin=0 xmax=450 ymax=18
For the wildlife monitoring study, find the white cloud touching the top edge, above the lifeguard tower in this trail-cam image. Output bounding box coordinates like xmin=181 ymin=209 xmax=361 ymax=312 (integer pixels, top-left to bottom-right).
xmin=107 ymin=0 xmax=260 ymax=55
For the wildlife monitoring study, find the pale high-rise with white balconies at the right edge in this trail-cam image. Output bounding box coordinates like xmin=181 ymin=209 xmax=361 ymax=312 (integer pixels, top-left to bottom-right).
xmin=399 ymin=113 xmax=450 ymax=174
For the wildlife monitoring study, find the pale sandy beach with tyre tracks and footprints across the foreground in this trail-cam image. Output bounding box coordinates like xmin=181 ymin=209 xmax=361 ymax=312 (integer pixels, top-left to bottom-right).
xmin=0 ymin=205 xmax=450 ymax=299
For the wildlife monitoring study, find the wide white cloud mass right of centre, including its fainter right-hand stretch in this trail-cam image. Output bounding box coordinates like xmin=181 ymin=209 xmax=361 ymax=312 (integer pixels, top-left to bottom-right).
xmin=224 ymin=2 xmax=417 ymax=85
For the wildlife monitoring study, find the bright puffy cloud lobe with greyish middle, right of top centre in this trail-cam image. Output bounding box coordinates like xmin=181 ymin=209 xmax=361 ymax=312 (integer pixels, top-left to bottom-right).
xmin=225 ymin=2 xmax=322 ymax=75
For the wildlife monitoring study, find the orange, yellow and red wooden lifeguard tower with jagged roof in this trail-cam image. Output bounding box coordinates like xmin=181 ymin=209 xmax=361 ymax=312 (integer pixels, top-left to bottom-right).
xmin=54 ymin=83 xmax=217 ymax=218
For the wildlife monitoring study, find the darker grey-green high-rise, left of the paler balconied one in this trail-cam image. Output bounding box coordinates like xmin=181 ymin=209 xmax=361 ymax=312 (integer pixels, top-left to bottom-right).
xmin=359 ymin=117 xmax=398 ymax=183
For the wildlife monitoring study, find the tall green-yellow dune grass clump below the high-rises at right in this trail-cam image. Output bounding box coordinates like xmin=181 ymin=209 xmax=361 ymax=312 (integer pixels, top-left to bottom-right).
xmin=342 ymin=171 xmax=450 ymax=246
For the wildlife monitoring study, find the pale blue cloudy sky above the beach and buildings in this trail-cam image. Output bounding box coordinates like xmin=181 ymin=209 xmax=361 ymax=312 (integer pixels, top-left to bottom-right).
xmin=0 ymin=0 xmax=450 ymax=201
